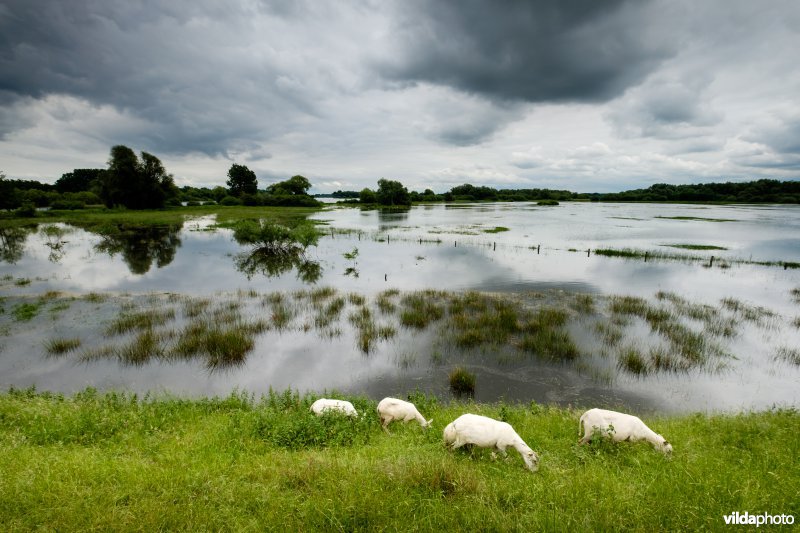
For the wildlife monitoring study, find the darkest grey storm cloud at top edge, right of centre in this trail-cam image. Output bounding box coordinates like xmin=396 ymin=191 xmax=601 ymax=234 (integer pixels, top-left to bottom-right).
xmin=378 ymin=0 xmax=673 ymax=102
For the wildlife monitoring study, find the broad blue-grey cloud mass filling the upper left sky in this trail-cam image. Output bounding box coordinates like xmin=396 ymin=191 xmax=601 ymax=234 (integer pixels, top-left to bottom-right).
xmin=0 ymin=0 xmax=328 ymax=155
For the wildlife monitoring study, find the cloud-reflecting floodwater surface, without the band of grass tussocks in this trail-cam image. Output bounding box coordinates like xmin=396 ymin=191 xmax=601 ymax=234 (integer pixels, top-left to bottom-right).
xmin=0 ymin=203 xmax=800 ymax=411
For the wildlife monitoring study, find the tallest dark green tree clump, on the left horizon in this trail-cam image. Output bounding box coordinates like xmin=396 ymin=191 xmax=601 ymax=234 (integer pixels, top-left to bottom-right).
xmin=100 ymin=145 xmax=178 ymax=209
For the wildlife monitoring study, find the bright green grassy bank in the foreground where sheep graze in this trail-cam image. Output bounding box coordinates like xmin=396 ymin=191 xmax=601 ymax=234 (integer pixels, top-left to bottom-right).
xmin=0 ymin=390 xmax=800 ymax=531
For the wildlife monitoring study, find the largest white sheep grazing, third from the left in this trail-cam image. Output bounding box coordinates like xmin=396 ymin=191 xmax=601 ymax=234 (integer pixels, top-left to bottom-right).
xmin=444 ymin=414 xmax=539 ymax=472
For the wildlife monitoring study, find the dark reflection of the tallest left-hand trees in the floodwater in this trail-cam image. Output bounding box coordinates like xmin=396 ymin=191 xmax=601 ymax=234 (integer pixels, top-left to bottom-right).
xmin=94 ymin=223 xmax=183 ymax=274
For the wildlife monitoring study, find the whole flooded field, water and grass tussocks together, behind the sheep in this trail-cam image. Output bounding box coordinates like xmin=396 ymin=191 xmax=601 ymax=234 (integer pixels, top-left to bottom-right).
xmin=0 ymin=203 xmax=800 ymax=411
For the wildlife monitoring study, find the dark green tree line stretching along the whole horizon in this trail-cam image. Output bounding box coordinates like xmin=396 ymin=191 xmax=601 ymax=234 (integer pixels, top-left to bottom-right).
xmin=0 ymin=145 xmax=800 ymax=214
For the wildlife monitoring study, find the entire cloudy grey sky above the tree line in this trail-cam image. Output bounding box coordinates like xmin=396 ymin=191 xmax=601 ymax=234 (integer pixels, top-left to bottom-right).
xmin=0 ymin=0 xmax=800 ymax=192
